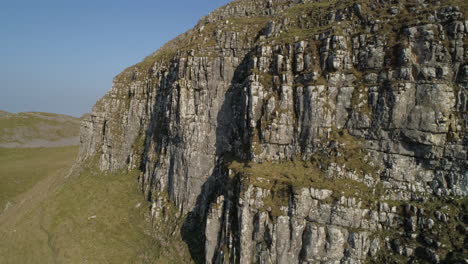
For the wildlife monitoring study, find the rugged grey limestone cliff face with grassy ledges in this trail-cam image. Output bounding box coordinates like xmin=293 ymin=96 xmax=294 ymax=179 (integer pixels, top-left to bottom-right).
xmin=80 ymin=0 xmax=468 ymax=263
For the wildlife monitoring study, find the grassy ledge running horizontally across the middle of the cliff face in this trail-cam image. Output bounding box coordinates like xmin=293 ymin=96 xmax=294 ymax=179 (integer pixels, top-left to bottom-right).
xmin=228 ymin=154 xmax=381 ymax=216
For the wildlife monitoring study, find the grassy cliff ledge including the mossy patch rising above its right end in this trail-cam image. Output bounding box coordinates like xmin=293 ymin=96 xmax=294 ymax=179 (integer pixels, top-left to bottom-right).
xmin=227 ymin=128 xmax=384 ymax=216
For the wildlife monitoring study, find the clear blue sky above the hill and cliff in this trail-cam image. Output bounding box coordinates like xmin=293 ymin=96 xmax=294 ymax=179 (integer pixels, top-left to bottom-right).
xmin=0 ymin=0 xmax=229 ymax=116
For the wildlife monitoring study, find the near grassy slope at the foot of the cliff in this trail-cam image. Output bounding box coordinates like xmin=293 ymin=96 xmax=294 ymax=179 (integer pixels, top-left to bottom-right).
xmin=0 ymin=168 xmax=151 ymax=263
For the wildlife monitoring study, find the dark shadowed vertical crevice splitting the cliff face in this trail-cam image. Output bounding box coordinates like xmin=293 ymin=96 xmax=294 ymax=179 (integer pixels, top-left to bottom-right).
xmin=181 ymin=50 xmax=251 ymax=263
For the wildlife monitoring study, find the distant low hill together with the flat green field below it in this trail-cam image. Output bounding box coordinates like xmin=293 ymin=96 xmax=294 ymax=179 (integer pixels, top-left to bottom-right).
xmin=0 ymin=111 xmax=80 ymax=213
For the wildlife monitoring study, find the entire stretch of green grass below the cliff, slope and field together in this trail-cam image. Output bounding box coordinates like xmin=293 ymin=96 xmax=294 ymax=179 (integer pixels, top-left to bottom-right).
xmin=0 ymin=147 xmax=191 ymax=263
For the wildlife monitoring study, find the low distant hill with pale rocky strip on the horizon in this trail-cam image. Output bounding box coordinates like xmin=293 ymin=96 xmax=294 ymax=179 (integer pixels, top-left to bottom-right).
xmin=0 ymin=111 xmax=80 ymax=148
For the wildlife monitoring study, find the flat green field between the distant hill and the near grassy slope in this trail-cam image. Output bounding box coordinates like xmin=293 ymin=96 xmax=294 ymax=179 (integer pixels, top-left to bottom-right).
xmin=0 ymin=146 xmax=78 ymax=212
